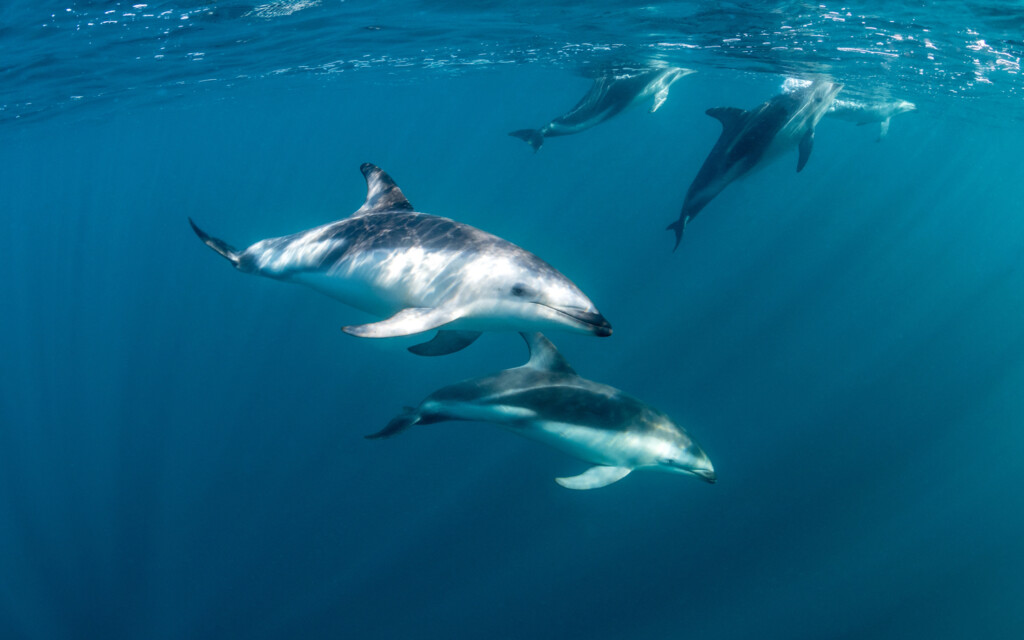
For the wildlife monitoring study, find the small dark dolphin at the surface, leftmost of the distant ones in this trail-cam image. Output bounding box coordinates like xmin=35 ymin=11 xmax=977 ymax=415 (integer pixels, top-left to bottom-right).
xmin=509 ymin=67 xmax=696 ymax=153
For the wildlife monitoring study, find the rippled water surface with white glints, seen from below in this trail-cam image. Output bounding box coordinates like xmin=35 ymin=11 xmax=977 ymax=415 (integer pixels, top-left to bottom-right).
xmin=6 ymin=0 xmax=1024 ymax=120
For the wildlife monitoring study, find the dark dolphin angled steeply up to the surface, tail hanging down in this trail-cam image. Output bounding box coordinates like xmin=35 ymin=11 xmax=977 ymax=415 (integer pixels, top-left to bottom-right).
xmin=668 ymin=80 xmax=843 ymax=248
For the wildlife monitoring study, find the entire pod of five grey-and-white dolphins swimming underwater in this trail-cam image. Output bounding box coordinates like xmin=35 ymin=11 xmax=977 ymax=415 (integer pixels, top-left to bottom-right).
xmin=188 ymin=68 xmax=897 ymax=489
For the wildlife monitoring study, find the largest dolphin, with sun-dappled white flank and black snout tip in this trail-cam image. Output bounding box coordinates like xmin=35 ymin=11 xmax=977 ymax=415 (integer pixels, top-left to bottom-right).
xmin=188 ymin=163 xmax=611 ymax=355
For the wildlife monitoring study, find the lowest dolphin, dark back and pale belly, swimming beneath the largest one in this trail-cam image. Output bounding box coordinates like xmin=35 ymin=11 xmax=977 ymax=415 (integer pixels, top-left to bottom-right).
xmin=367 ymin=333 xmax=716 ymax=489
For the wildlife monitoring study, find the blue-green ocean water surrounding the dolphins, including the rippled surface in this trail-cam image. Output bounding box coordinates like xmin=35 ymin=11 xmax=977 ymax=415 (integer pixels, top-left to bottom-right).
xmin=0 ymin=0 xmax=1024 ymax=640
